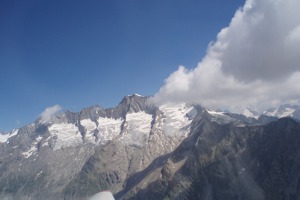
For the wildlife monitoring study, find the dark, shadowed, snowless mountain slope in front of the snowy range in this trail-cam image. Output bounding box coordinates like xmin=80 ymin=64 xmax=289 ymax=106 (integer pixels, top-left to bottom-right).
xmin=130 ymin=112 xmax=300 ymax=200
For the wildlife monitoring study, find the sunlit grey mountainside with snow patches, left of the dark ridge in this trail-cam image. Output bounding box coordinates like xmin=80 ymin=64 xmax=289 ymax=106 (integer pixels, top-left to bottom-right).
xmin=0 ymin=94 xmax=202 ymax=199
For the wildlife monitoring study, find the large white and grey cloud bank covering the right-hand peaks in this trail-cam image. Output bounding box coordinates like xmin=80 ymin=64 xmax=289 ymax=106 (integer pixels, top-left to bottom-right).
xmin=153 ymin=0 xmax=300 ymax=111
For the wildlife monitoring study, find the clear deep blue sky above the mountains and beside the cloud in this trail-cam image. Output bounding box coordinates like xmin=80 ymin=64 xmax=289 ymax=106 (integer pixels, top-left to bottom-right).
xmin=0 ymin=0 xmax=245 ymax=130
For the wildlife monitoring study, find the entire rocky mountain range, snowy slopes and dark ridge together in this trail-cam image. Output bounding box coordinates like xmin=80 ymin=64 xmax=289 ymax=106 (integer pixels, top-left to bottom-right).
xmin=0 ymin=94 xmax=300 ymax=200
